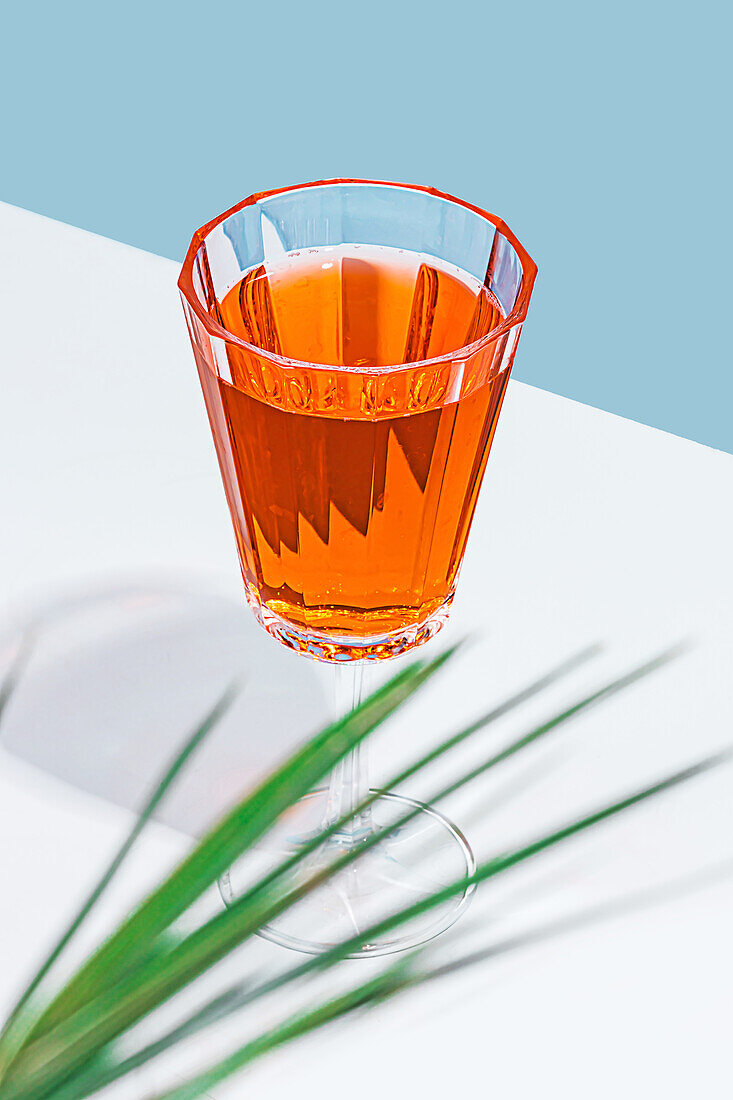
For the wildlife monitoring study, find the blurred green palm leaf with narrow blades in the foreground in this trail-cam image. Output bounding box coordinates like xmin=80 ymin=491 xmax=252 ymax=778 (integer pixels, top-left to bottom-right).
xmin=0 ymin=650 xmax=718 ymax=1100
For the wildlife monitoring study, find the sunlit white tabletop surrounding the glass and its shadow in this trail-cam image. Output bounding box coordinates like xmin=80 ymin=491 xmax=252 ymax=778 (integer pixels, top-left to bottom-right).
xmin=0 ymin=206 xmax=733 ymax=1100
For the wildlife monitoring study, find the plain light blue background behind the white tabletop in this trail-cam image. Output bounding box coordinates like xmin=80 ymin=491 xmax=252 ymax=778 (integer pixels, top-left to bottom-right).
xmin=0 ymin=0 xmax=733 ymax=450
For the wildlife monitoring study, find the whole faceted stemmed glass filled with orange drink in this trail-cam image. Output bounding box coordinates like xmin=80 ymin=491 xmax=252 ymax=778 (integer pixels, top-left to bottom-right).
xmin=178 ymin=179 xmax=536 ymax=955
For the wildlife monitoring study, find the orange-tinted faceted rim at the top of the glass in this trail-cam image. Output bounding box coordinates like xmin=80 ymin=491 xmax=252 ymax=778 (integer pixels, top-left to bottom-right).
xmin=173 ymin=178 xmax=537 ymax=375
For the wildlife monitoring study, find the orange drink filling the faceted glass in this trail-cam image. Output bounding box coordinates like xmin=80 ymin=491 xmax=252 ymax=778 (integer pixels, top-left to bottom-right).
xmin=211 ymin=245 xmax=508 ymax=639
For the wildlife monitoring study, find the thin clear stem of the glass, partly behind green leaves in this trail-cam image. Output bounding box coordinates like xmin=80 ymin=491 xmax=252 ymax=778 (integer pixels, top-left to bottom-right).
xmin=324 ymin=661 xmax=372 ymax=846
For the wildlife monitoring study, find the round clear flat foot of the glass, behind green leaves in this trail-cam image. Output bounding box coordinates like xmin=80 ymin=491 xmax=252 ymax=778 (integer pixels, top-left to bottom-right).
xmin=219 ymin=791 xmax=475 ymax=958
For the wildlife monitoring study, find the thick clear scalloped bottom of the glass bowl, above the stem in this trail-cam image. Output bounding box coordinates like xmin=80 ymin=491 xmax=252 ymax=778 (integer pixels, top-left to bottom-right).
xmin=247 ymin=589 xmax=453 ymax=663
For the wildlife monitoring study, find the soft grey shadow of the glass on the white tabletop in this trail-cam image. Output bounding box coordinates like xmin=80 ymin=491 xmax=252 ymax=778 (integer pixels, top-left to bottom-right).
xmin=0 ymin=583 xmax=328 ymax=835
